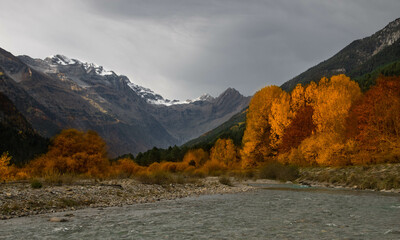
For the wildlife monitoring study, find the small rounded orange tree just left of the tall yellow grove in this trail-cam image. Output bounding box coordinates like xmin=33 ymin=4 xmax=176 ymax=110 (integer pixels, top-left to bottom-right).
xmin=210 ymin=139 xmax=238 ymax=168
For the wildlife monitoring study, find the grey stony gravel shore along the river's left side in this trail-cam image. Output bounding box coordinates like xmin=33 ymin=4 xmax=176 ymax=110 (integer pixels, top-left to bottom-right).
xmin=0 ymin=177 xmax=255 ymax=219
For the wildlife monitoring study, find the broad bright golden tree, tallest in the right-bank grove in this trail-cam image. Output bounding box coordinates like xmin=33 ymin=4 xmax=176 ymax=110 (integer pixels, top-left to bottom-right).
xmin=299 ymin=74 xmax=362 ymax=166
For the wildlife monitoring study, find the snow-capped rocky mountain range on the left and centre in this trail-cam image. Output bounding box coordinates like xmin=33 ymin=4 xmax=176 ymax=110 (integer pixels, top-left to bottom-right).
xmin=0 ymin=49 xmax=249 ymax=156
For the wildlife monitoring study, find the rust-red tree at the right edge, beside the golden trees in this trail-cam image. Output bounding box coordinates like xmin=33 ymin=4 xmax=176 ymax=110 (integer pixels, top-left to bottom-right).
xmin=347 ymin=76 xmax=400 ymax=164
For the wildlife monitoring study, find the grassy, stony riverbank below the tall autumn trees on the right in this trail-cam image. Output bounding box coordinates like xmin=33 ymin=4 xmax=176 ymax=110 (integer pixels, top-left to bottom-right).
xmin=296 ymin=164 xmax=400 ymax=193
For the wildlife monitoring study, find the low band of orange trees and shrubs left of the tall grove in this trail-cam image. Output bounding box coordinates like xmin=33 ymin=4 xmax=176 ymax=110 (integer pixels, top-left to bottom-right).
xmin=0 ymin=129 xmax=239 ymax=181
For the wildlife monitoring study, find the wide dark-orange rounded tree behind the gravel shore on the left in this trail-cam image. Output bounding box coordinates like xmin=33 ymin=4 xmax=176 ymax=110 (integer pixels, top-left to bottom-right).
xmin=28 ymin=129 xmax=109 ymax=177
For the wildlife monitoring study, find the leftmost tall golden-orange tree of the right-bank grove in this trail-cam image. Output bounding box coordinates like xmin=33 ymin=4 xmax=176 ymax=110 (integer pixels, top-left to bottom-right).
xmin=240 ymin=86 xmax=283 ymax=168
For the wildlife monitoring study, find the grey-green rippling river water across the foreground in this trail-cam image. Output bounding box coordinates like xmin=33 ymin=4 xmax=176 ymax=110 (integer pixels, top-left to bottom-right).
xmin=0 ymin=185 xmax=400 ymax=240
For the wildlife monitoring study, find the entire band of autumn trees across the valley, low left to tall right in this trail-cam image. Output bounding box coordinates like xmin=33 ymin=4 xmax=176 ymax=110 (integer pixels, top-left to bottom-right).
xmin=0 ymin=75 xmax=400 ymax=179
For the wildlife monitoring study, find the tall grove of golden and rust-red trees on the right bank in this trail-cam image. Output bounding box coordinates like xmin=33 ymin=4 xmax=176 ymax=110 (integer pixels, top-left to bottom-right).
xmin=241 ymin=74 xmax=400 ymax=167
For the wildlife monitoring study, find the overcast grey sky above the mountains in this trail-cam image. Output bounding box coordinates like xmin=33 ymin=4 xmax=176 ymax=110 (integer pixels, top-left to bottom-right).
xmin=0 ymin=0 xmax=400 ymax=100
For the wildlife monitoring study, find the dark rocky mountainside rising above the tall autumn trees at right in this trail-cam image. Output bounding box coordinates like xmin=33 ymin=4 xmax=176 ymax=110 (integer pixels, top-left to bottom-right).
xmin=281 ymin=18 xmax=400 ymax=91
